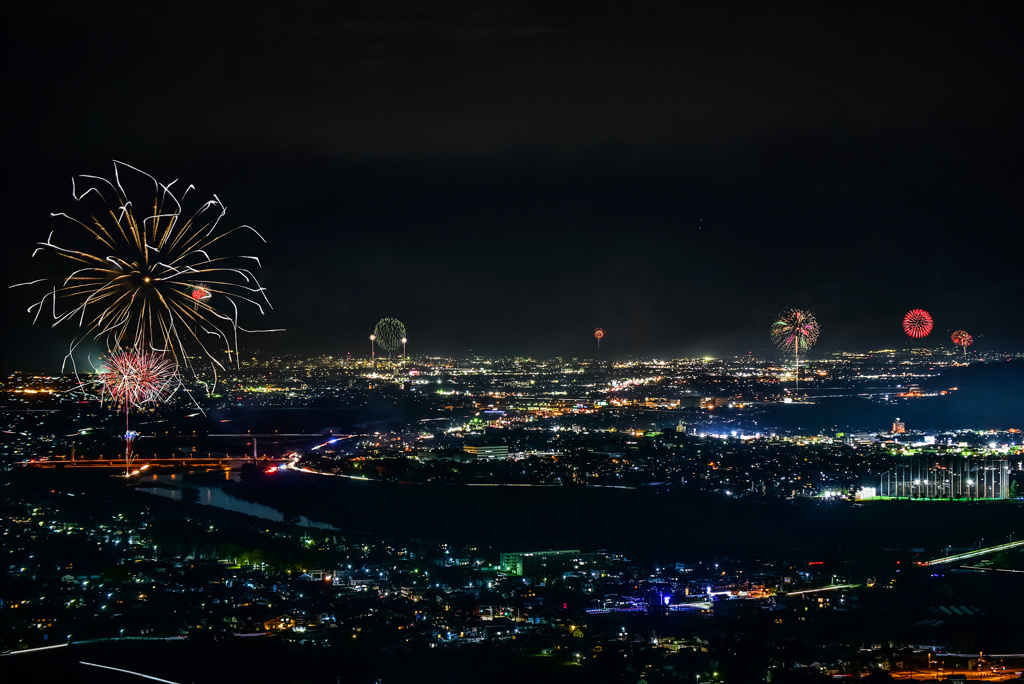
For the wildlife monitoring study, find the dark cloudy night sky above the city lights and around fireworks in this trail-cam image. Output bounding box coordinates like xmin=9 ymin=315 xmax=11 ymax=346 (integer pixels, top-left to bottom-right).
xmin=0 ymin=0 xmax=1024 ymax=371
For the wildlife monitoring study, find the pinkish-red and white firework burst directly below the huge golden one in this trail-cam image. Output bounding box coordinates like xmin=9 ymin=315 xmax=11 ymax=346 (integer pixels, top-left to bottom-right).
xmin=99 ymin=351 xmax=179 ymax=411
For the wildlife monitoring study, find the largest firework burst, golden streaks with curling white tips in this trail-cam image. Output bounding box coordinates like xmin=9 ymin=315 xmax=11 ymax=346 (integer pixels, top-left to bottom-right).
xmin=14 ymin=162 xmax=284 ymax=385
